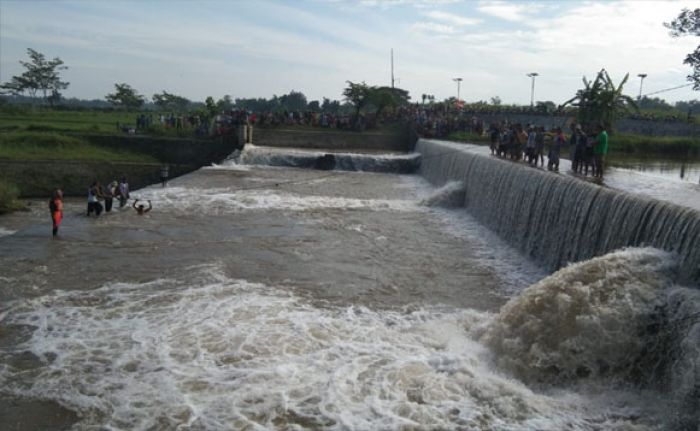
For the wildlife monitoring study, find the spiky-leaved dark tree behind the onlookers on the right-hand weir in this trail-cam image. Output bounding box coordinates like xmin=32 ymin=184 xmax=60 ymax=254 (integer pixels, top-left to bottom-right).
xmin=562 ymin=69 xmax=637 ymax=131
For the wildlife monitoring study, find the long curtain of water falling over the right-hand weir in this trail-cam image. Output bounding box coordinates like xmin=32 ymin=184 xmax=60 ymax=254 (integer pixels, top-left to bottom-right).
xmin=416 ymin=139 xmax=700 ymax=285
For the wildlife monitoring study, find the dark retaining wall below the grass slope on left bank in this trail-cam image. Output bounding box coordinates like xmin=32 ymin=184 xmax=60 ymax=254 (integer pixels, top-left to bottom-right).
xmin=0 ymin=160 xmax=199 ymax=197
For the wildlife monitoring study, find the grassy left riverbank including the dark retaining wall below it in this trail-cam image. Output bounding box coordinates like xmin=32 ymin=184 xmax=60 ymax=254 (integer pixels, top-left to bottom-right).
xmin=0 ymin=131 xmax=237 ymax=201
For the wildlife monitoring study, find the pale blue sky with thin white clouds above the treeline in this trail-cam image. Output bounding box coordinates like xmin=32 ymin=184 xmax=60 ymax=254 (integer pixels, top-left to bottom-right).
xmin=0 ymin=0 xmax=700 ymax=104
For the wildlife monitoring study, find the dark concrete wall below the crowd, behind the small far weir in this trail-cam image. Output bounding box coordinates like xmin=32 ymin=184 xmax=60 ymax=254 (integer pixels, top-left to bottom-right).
xmin=253 ymin=127 xmax=415 ymax=152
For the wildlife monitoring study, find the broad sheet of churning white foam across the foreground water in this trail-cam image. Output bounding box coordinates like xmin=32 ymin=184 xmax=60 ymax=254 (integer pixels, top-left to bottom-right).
xmin=0 ymin=266 xmax=680 ymax=430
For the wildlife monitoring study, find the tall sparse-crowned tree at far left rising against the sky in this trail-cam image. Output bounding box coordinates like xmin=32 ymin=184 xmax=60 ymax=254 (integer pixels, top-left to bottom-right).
xmin=0 ymin=48 xmax=70 ymax=104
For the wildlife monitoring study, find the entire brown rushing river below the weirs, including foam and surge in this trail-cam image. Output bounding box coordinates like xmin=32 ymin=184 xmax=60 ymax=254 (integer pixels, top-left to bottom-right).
xmin=0 ymin=147 xmax=700 ymax=430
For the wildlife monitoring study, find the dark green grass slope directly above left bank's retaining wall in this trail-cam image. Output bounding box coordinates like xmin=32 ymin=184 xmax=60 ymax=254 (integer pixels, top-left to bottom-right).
xmin=0 ymin=132 xmax=158 ymax=163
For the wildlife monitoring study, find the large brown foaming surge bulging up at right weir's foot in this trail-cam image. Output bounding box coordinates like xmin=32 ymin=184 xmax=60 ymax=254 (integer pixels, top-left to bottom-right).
xmin=483 ymin=248 xmax=675 ymax=383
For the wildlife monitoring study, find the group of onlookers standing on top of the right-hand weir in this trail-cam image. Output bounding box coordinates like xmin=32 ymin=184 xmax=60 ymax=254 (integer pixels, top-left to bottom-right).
xmin=488 ymin=123 xmax=608 ymax=178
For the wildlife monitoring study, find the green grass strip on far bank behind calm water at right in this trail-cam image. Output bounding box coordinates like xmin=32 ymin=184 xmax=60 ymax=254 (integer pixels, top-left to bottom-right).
xmin=608 ymin=133 xmax=700 ymax=156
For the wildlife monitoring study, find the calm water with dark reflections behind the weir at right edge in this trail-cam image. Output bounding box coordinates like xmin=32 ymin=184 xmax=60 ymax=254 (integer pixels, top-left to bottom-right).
xmin=609 ymin=154 xmax=700 ymax=184
